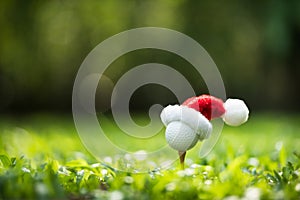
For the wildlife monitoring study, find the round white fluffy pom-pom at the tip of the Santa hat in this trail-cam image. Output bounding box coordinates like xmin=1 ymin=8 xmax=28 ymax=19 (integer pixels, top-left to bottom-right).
xmin=223 ymin=99 xmax=249 ymax=126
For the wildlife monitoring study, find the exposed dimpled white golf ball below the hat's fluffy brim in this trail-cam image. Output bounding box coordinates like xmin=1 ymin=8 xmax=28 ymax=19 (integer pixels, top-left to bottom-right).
xmin=166 ymin=121 xmax=198 ymax=152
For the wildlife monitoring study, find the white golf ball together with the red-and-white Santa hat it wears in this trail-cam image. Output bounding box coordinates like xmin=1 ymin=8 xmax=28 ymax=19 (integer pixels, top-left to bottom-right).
xmin=160 ymin=95 xmax=249 ymax=152
